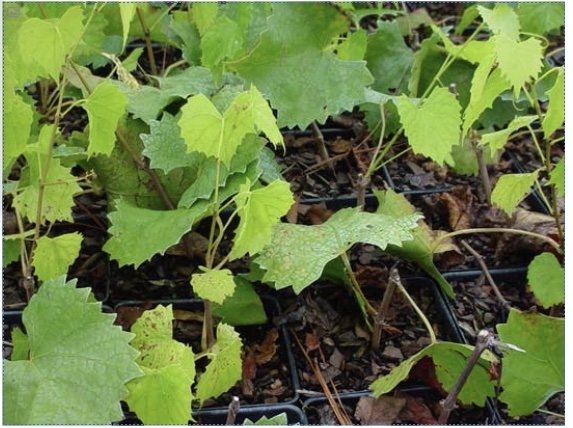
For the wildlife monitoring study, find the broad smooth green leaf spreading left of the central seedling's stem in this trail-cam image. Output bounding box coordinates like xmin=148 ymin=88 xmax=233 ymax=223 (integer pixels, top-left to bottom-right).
xmin=103 ymin=199 xmax=209 ymax=268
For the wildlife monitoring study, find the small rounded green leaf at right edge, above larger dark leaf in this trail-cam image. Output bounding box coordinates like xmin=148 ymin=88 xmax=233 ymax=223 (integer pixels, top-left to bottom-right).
xmin=527 ymin=253 xmax=565 ymax=308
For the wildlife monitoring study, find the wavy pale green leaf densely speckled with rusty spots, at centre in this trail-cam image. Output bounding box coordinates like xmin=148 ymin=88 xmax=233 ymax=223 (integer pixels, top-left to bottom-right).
xmin=255 ymin=208 xmax=420 ymax=293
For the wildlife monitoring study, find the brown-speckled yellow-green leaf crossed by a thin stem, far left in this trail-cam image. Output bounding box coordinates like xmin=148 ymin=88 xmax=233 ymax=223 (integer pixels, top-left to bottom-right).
xmin=14 ymin=154 xmax=82 ymax=224
